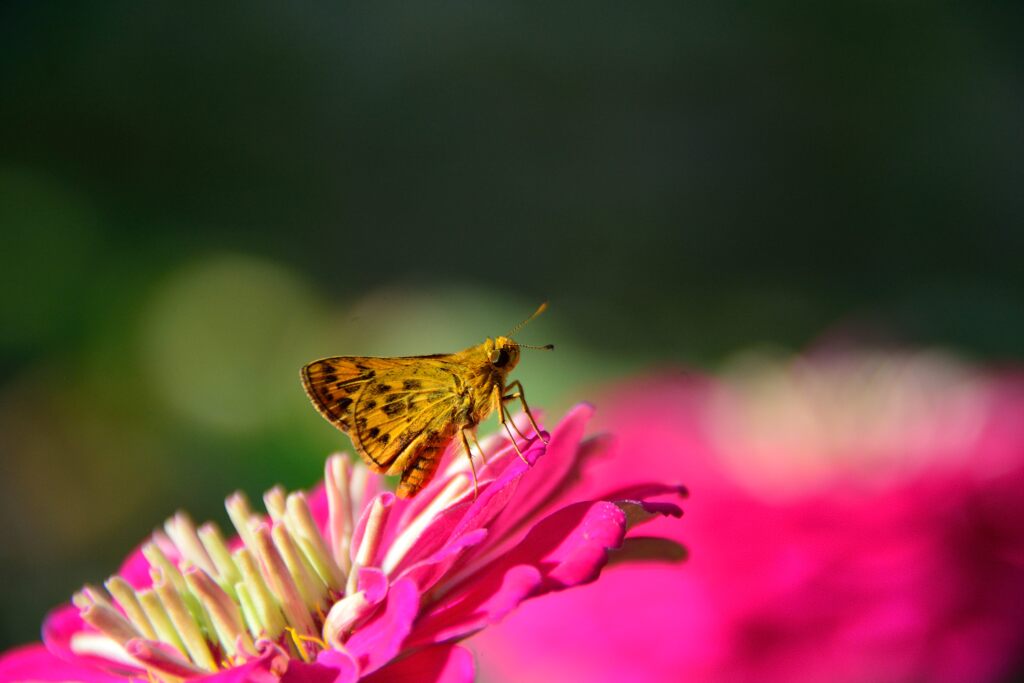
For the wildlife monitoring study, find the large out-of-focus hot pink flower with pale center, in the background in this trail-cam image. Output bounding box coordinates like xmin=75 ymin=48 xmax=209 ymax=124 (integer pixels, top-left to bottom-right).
xmin=472 ymin=352 xmax=1024 ymax=683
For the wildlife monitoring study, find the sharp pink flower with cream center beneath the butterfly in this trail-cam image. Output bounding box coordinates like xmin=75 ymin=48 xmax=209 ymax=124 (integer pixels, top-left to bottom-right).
xmin=0 ymin=405 xmax=682 ymax=683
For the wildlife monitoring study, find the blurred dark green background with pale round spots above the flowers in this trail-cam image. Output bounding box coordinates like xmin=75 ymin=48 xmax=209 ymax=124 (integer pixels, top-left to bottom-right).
xmin=0 ymin=1 xmax=1024 ymax=667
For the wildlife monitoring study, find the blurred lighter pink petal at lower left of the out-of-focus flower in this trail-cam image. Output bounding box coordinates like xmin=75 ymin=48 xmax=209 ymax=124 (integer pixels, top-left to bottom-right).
xmin=469 ymin=553 xmax=696 ymax=683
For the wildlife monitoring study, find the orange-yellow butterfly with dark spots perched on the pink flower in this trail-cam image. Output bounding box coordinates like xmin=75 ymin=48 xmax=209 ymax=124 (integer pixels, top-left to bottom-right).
xmin=301 ymin=303 xmax=554 ymax=498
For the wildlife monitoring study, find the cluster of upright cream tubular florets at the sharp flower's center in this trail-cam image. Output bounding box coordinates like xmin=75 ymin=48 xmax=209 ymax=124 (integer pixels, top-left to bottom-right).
xmin=72 ymin=456 xmax=389 ymax=676
